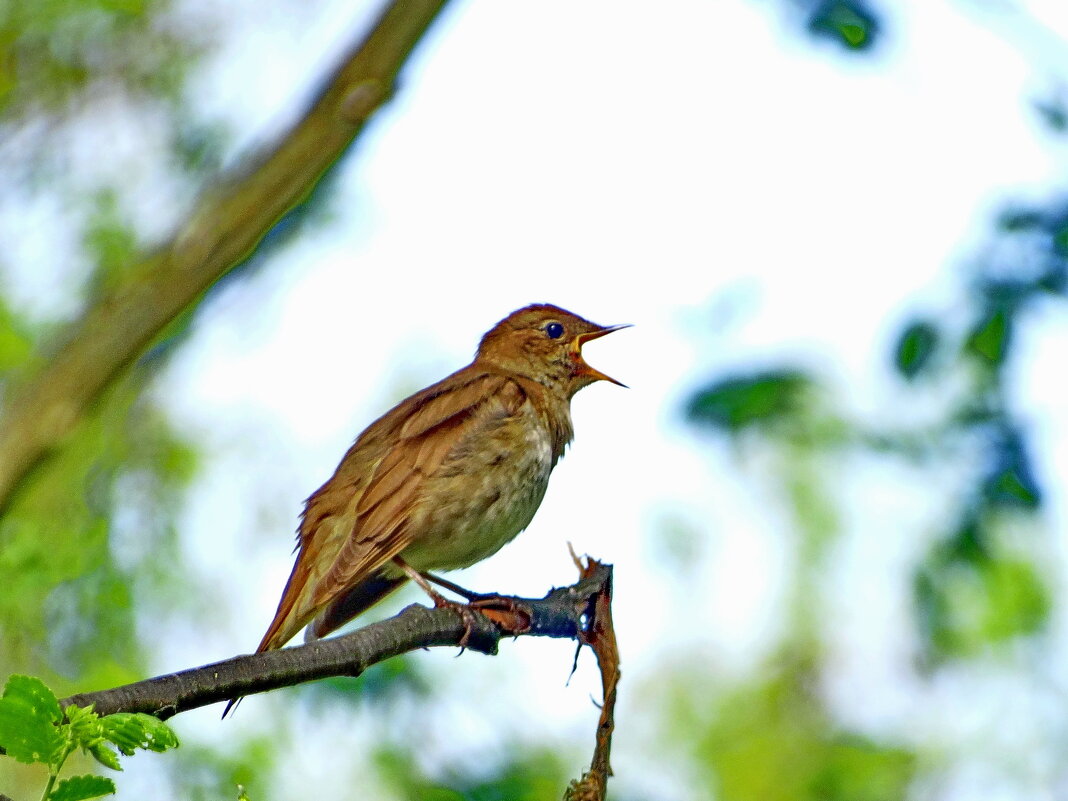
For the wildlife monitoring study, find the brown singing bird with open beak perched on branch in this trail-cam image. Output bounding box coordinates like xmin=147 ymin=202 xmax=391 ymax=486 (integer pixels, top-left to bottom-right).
xmin=250 ymin=304 xmax=627 ymax=650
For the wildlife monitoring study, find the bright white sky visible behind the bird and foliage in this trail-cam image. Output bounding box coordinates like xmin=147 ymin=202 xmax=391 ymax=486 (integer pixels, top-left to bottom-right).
xmin=2 ymin=0 xmax=1068 ymax=801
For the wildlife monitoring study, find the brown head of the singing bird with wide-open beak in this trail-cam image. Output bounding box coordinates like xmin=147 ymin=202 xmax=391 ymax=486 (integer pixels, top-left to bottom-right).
xmin=476 ymin=303 xmax=629 ymax=398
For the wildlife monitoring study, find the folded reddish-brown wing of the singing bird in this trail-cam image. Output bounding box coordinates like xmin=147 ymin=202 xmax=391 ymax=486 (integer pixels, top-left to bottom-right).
xmin=260 ymin=373 xmax=523 ymax=650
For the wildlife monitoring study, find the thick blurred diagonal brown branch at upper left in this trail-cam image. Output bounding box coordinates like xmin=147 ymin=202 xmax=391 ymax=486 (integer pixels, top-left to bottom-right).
xmin=0 ymin=0 xmax=446 ymax=509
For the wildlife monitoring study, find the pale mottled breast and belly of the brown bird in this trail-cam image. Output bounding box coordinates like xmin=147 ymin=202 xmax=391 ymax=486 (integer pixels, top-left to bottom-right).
xmin=401 ymin=403 xmax=554 ymax=570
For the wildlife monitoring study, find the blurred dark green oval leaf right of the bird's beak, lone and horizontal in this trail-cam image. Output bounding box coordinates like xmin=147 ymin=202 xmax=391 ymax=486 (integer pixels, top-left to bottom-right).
xmin=687 ymin=370 xmax=811 ymax=433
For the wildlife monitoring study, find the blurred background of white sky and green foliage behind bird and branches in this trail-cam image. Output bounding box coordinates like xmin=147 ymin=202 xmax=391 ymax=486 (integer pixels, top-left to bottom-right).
xmin=0 ymin=0 xmax=1068 ymax=801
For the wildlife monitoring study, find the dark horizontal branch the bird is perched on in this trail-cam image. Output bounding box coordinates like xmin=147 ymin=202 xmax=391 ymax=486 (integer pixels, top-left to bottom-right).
xmin=60 ymin=560 xmax=612 ymax=720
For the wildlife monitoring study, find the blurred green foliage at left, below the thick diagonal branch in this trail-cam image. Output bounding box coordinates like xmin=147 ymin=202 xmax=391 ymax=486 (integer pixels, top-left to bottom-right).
xmin=0 ymin=370 xmax=195 ymax=693
